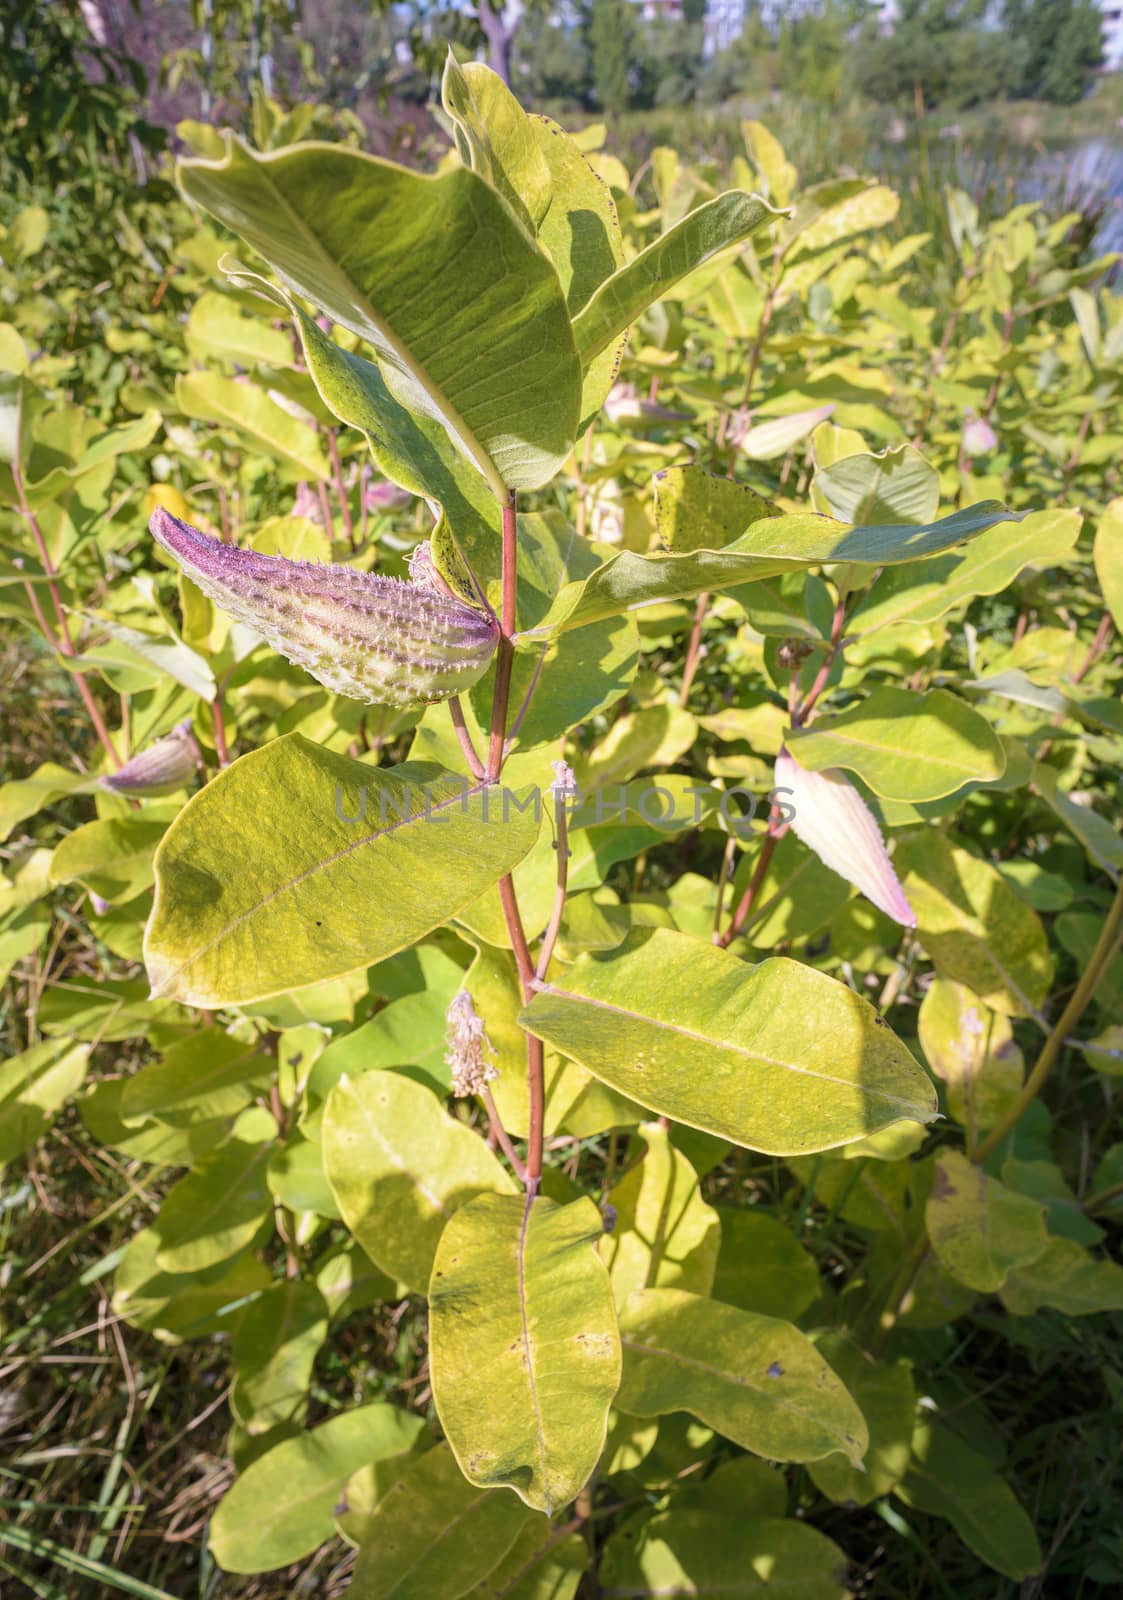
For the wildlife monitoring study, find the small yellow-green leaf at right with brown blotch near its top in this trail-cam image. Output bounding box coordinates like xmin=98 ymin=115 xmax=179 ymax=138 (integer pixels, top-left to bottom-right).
xmin=925 ymin=1150 xmax=1048 ymax=1294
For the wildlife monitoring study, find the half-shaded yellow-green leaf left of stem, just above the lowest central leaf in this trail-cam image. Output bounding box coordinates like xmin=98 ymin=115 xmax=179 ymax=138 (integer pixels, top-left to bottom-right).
xmin=323 ymin=1072 xmax=515 ymax=1294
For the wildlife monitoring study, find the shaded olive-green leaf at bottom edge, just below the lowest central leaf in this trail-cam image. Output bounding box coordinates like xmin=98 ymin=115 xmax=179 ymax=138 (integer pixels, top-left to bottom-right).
xmin=347 ymin=1445 xmax=546 ymax=1600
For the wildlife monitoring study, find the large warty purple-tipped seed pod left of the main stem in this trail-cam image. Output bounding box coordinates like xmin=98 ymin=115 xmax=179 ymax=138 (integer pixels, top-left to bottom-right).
xmin=149 ymin=509 xmax=499 ymax=709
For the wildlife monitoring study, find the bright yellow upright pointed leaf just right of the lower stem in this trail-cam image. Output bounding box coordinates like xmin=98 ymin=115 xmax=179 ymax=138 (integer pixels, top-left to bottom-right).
xmin=601 ymin=1122 xmax=721 ymax=1306
